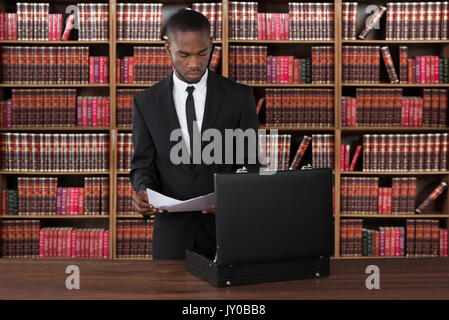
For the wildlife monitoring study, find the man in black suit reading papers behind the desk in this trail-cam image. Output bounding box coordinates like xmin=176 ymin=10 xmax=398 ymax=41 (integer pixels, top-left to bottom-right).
xmin=130 ymin=10 xmax=259 ymax=259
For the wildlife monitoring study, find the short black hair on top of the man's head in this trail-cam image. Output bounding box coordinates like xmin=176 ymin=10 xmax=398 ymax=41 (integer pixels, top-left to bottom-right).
xmin=166 ymin=9 xmax=210 ymax=37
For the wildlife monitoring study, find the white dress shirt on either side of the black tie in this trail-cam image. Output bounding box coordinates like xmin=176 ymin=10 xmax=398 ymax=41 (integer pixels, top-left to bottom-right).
xmin=173 ymin=69 xmax=208 ymax=154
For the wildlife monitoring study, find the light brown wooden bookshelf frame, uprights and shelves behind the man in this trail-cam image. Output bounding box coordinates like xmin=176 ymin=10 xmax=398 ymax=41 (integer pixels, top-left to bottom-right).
xmin=0 ymin=0 xmax=449 ymax=260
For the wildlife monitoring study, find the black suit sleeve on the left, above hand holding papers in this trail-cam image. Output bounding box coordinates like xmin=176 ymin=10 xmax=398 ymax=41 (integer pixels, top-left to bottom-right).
xmin=130 ymin=96 xmax=160 ymax=192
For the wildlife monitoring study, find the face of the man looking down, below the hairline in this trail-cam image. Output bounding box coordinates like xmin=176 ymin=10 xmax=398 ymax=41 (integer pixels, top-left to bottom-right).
xmin=165 ymin=31 xmax=212 ymax=83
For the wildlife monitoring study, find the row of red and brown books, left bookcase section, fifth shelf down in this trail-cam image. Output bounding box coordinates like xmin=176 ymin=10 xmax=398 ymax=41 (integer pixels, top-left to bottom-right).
xmin=0 ymin=177 xmax=109 ymax=216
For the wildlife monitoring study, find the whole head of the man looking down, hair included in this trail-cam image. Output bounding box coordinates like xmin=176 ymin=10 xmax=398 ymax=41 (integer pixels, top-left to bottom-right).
xmin=165 ymin=10 xmax=212 ymax=83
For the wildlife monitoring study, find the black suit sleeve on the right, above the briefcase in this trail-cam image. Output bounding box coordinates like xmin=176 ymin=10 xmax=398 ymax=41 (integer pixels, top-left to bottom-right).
xmin=235 ymin=87 xmax=259 ymax=172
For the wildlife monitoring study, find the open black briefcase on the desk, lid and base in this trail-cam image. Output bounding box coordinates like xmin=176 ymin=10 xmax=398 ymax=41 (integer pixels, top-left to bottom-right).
xmin=186 ymin=169 xmax=333 ymax=286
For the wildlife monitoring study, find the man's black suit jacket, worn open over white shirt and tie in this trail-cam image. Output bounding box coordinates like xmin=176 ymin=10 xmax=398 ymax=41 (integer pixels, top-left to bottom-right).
xmin=130 ymin=70 xmax=259 ymax=259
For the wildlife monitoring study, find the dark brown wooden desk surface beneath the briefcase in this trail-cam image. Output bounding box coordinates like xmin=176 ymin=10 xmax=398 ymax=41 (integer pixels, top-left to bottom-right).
xmin=0 ymin=259 xmax=449 ymax=300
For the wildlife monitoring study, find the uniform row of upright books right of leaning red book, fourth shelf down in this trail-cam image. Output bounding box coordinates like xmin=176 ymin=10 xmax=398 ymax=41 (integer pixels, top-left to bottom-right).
xmin=362 ymin=133 xmax=449 ymax=171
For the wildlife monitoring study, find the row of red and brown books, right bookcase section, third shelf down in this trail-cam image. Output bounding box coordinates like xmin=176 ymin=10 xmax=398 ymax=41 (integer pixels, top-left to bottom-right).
xmin=341 ymin=88 xmax=448 ymax=127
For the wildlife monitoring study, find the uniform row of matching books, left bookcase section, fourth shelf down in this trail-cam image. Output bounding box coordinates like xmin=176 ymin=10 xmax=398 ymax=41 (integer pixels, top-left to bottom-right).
xmin=0 ymin=132 xmax=109 ymax=172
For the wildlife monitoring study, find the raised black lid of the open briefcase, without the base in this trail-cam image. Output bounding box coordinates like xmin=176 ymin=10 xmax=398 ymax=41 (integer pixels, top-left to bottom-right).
xmin=214 ymin=168 xmax=332 ymax=266
